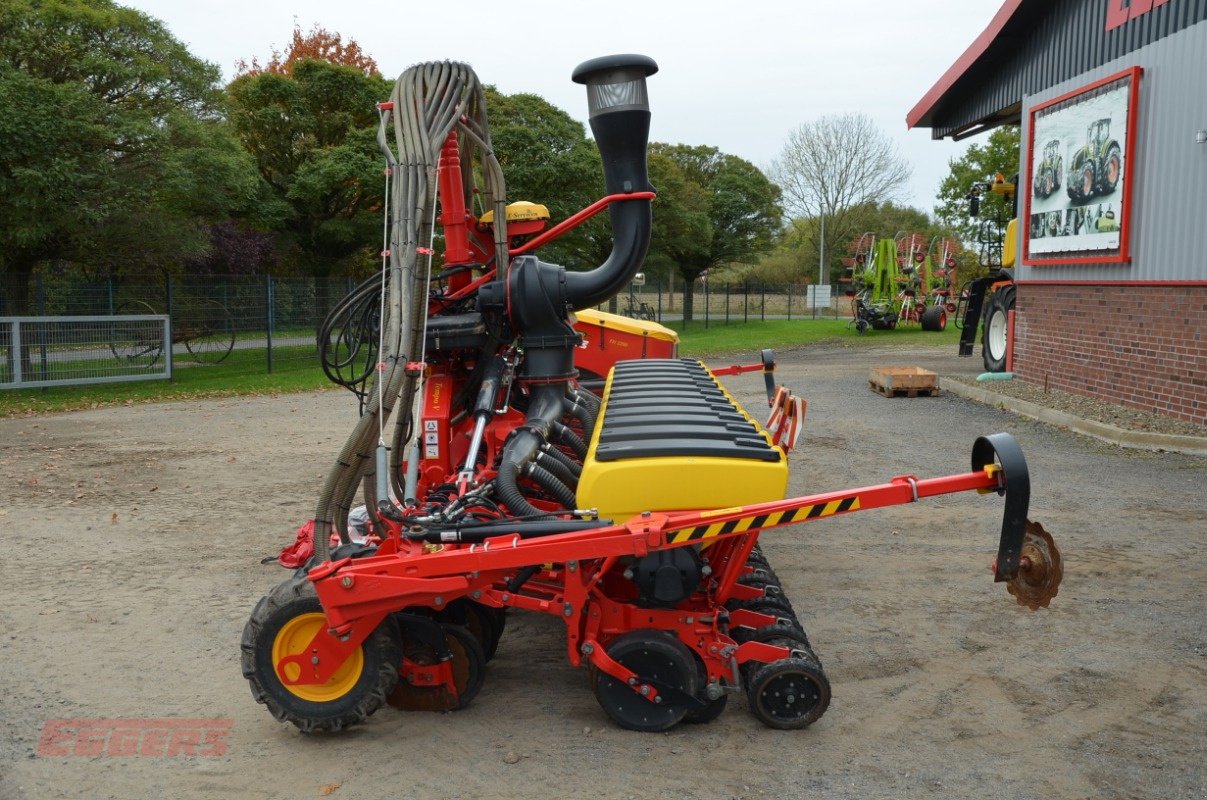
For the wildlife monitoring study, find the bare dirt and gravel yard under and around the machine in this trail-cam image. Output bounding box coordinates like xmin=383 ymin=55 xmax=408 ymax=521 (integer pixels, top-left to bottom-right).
xmin=0 ymin=349 xmax=1207 ymax=800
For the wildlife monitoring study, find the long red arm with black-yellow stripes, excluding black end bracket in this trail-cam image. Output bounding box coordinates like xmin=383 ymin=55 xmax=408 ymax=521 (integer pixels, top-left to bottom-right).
xmin=278 ymin=466 xmax=1003 ymax=685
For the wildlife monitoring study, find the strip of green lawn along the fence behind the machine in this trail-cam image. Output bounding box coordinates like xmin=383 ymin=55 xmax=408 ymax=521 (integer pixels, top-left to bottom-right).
xmin=0 ymin=320 xmax=960 ymax=416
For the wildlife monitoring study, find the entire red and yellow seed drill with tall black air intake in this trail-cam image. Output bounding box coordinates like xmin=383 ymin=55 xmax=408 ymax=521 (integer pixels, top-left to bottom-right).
xmin=241 ymin=56 xmax=1061 ymax=732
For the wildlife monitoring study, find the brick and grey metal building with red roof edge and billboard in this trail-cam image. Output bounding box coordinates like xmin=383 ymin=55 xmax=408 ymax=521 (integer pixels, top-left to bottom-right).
xmin=906 ymin=0 xmax=1207 ymax=425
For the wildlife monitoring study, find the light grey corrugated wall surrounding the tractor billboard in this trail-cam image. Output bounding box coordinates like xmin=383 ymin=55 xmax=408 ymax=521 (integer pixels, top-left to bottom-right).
xmin=1016 ymin=20 xmax=1207 ymax=281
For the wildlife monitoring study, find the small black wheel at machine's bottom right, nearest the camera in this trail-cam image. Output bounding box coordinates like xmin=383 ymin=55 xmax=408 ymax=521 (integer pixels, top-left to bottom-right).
xmin=746 ymin=658 xmax=830 ymax=730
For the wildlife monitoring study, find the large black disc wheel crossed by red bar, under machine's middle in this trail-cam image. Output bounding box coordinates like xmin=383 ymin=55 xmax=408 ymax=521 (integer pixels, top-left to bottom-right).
xmin=594 ymin=630 xmax=700 ymax=732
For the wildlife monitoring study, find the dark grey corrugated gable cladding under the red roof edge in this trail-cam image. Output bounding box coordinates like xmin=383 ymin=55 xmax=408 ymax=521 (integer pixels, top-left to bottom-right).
xmin=933 ymin=0 xmax=1207 ymax=139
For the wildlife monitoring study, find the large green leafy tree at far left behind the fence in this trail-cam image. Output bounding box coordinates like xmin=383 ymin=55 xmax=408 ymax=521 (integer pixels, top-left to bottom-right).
xmin=0 ymin=0 xmax=256 ymax=314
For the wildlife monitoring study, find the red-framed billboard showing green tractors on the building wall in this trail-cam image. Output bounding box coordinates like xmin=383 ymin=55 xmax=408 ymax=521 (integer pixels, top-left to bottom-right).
xmin=1020 ymin=70 xmax=1139 ymax=264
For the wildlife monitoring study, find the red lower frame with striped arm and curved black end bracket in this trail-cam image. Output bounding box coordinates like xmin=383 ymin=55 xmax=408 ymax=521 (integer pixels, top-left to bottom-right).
xmin=276 ymin=434 xmax=1030 ymax=702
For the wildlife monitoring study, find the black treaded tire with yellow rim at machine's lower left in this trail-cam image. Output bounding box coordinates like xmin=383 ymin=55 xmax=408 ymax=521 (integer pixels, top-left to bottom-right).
xmin=240 ymin=576 xmax=402 ymax=734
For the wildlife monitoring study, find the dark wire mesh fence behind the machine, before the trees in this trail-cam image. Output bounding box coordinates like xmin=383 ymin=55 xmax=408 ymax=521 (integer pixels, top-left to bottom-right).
xmin=0 ymin=270 xmax=847 ymax=386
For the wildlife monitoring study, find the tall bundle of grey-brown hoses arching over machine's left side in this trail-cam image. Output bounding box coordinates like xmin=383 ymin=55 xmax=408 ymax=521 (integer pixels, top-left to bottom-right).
xmin=314 ymin=62 xmax=507 ymax=560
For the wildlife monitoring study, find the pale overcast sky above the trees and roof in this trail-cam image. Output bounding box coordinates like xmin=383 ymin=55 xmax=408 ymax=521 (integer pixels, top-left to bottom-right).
xmin=118 ymin=0 xmax=1002 ymax=212
